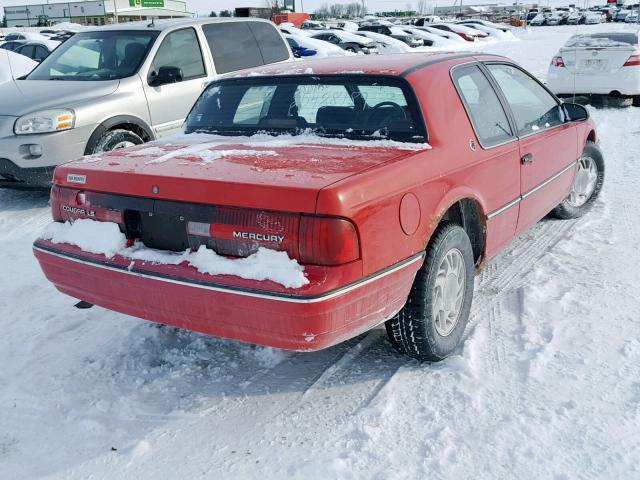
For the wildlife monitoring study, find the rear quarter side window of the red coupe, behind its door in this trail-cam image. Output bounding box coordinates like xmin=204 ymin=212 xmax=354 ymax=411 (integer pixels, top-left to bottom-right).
xmin=454 ymin=65 xmax=514 ymax=147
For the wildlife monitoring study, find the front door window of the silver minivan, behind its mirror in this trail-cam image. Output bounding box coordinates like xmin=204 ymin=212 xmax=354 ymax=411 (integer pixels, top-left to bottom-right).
xmin=149 ymin=28 xmax=205 ymax=80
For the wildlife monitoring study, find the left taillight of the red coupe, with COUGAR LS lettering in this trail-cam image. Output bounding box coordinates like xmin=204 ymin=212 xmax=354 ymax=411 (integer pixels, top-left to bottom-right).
xmin=51 ymin=185 xmax=124 ymax=227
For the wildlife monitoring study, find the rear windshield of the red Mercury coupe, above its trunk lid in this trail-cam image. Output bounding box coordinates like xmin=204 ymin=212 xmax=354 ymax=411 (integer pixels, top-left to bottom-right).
xmin=186 ymin=75 xmax=427 ymax=143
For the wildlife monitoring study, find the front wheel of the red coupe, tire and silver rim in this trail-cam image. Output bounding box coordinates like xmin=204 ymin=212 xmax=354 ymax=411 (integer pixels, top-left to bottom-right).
xmin=551 ymin=142 xmax=604 ymax=220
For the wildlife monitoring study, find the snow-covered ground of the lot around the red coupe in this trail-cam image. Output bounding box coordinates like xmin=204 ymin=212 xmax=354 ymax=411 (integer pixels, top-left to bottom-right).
xmin=0 ymin=25 xmax=640 ymax=480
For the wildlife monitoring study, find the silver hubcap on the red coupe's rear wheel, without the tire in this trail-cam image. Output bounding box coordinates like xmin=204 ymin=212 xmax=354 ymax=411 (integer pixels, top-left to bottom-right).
xmin=433 ymin=248 xmax=467 ymax=337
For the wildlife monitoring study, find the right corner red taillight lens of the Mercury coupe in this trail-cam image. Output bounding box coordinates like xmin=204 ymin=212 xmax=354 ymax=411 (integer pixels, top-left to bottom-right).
xmin=299 ymin=215 xmax=360 ymax=266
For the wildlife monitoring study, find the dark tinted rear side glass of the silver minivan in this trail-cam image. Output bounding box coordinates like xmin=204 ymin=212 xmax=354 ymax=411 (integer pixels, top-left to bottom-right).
xmin=202 ymin=22 xmax=289 ymax=73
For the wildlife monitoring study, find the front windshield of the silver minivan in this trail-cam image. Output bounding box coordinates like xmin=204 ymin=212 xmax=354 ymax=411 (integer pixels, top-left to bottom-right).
xmin=27 ymin=30 xmax=158 ymax=81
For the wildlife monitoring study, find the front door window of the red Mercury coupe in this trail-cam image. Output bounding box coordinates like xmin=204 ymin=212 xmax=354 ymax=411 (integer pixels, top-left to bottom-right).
xmin=487 ymin=64 xmax=563 ymax=135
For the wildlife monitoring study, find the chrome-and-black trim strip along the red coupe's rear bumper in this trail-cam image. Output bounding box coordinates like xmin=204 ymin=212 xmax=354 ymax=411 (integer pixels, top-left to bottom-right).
xmin=33 ymin=245 xmax=424 ymax=304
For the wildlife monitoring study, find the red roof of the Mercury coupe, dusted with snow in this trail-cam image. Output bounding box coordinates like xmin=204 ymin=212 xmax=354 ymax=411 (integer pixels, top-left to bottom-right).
xmin=234 ymin=52 xmax=508 ymax=76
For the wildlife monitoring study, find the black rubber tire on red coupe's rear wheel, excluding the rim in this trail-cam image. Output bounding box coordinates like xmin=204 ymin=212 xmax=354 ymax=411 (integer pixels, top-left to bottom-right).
xmin=385 ymin=221 xmax=475 ymax=362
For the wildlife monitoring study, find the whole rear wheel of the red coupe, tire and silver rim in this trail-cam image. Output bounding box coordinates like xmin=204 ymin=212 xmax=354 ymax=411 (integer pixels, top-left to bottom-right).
xmin=386 ymin=221 xmax=474 ymax=362
